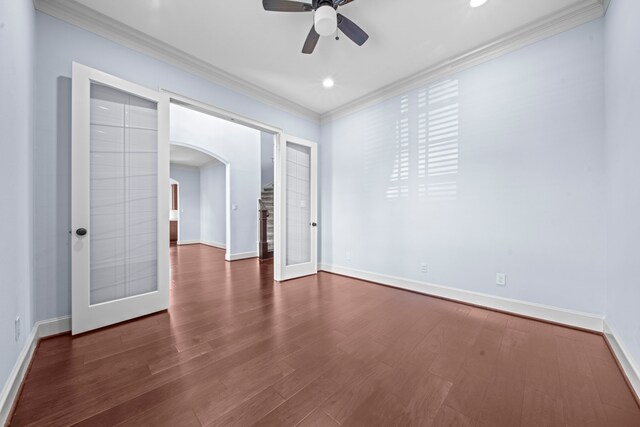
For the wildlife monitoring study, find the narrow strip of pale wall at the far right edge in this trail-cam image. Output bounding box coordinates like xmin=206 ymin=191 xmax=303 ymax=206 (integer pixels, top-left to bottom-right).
xmin=605 ymin=0 xmax=640 ymax=364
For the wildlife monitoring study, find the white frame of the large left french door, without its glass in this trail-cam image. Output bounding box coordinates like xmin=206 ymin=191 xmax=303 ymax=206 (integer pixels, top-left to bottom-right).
xmin=71 ymin=62 xmax=170 ymax=334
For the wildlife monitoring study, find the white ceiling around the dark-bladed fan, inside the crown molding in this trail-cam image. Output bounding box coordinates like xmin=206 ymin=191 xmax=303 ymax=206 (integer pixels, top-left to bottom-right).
xmin=40 ymin=0 xmax=608 ymax=114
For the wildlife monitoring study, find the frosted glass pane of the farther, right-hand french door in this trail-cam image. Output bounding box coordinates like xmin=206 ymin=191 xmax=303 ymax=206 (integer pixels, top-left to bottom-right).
xmin=286 ymin=142 xmax=311 ymax=266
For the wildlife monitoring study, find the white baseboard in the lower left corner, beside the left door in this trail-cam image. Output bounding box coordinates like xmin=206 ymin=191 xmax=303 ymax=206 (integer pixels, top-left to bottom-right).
xmin=0 ymin=316 xmax=71 ymax=425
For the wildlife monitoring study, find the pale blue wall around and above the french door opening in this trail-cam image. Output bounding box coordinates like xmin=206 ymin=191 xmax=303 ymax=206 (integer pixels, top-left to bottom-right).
xmin=31 ymin=11 xmax=319 ymax=320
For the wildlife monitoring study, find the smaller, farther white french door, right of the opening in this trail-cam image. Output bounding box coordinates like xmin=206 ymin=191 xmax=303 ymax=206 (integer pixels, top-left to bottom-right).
xmin=275 ymin=134 xmax=318 ymax=281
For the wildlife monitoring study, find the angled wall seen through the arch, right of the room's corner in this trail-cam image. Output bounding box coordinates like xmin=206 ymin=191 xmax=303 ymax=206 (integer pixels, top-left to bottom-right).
xmin=200 ymin=160 xmax=227 ymax=246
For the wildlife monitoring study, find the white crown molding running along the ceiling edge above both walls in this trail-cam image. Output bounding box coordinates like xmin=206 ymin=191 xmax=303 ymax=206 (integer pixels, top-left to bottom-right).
xmin=33 ymin=0 xmax=610 ymax=122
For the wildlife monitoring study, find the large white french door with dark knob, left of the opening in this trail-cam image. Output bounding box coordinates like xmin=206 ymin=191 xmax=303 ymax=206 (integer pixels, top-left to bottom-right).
xmin=71 ymin=63 xmax=170 ymax=334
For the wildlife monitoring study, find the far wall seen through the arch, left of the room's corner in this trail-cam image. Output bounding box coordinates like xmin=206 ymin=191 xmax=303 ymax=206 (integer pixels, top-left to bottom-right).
xmin=169 ymin=163 xmax=201 ymax=243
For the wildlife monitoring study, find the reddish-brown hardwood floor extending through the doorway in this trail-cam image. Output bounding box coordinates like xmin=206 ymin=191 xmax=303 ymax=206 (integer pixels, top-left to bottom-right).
xmin=11 ymin=245 xmax=640 ymax=427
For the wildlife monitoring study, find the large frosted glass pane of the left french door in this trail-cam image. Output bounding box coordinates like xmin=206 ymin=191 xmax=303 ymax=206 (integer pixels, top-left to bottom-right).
xmin=89 ymin=83 xmax=158 ymax=305
